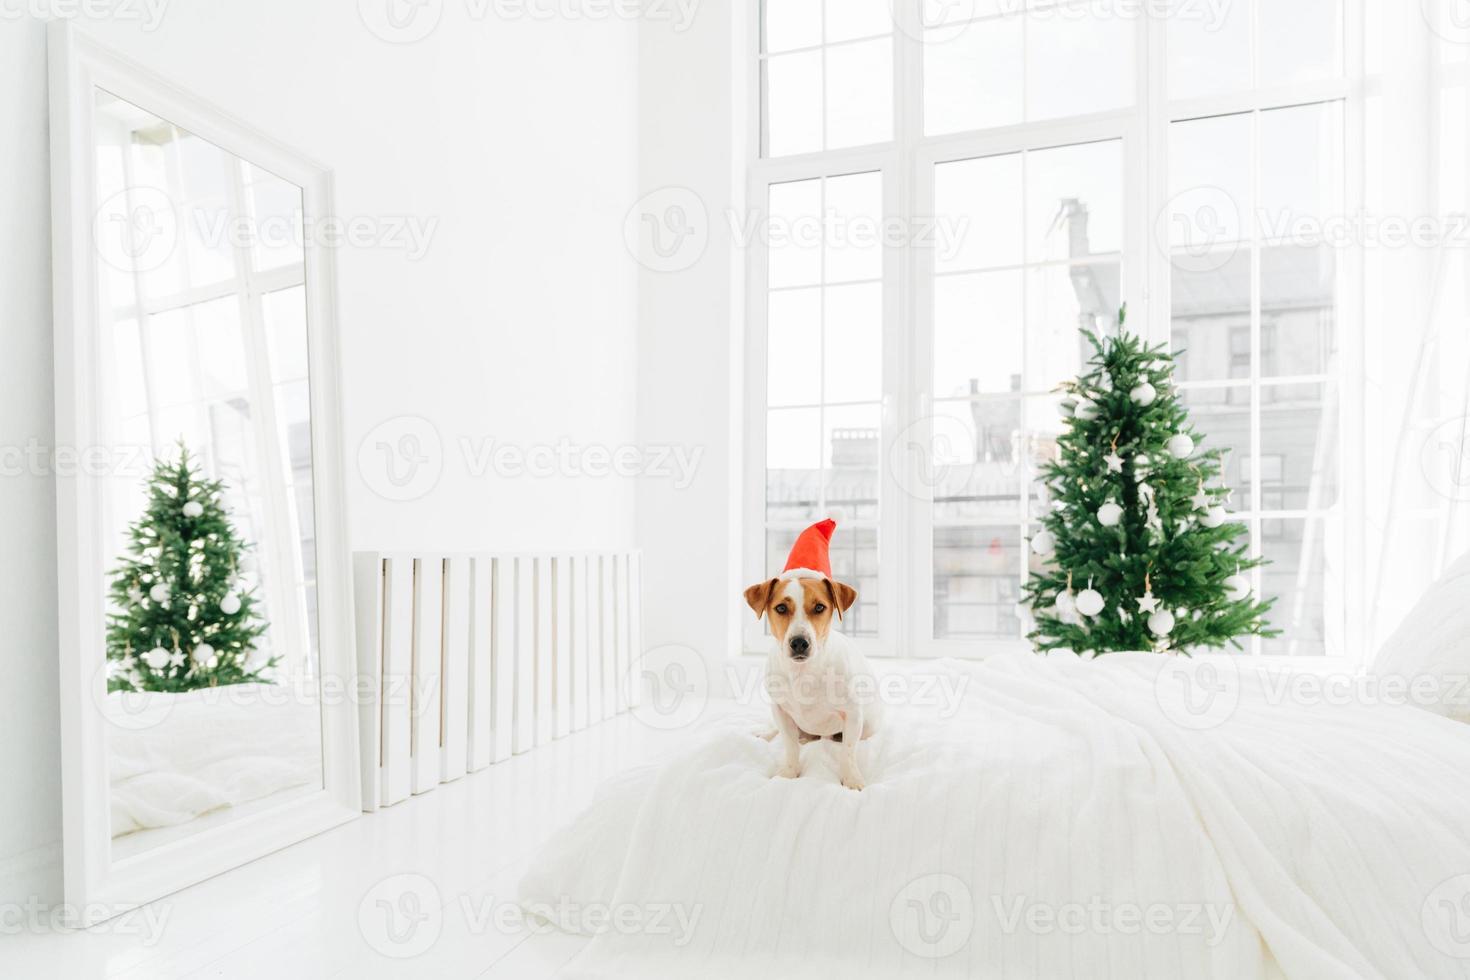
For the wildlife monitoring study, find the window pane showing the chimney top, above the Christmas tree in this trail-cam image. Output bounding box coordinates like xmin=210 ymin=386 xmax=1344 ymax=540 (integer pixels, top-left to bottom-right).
xmin=1026 ymin=140 xmax=1123 ymax=262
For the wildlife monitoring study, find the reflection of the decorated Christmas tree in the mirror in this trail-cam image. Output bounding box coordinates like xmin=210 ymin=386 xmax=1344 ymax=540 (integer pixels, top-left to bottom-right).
xmin=107 ymin=442 xmax=276 ymax=692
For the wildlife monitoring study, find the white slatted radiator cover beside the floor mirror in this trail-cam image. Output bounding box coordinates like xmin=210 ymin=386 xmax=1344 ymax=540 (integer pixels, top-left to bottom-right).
xmin=353 ymin=551 xmax=642 ymax=811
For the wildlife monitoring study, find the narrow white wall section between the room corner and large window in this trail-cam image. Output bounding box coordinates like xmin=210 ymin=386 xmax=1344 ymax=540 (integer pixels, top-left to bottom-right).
xmin=638 ymin=0 xmax=750 ymax=693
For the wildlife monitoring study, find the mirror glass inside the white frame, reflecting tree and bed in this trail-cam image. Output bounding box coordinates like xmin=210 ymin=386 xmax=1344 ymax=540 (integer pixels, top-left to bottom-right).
xmin=94 ymin=88 xmax=322 ymax=860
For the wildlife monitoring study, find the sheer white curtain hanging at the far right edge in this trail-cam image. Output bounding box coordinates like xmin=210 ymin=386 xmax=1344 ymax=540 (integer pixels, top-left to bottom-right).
xmin=1361 ymin=0 xmax=1470 ymax=660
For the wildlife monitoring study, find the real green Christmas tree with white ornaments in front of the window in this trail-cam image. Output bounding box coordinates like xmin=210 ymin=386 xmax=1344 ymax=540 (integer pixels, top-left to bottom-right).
xmin=1026 ymin=307 xmax=1274 ymax=654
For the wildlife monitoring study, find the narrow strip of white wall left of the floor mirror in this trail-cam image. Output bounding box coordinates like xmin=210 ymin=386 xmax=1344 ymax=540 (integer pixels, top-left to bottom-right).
xmin=0 ymin=13 xmax=62 ymax=902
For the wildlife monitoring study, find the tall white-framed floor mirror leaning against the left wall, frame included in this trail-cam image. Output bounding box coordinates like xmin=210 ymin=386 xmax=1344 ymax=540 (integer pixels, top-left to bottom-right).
xmin=49 ymin=22 xmax=359 ymax=926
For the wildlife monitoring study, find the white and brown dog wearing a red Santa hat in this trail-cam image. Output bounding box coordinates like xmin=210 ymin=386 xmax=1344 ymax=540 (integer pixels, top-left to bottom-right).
xmin=745 ymin=520 xmax=882 ymax=789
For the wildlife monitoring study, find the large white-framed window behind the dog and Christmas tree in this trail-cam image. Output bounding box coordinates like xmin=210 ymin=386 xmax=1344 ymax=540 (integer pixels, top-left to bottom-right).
xmin=745 ymin=0 xmax=1361 ymax=655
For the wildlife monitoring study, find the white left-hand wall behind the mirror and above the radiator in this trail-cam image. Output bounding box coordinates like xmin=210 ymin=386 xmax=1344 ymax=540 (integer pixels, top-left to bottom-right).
xmin=0 ymin=0 xmax=639 ymax=902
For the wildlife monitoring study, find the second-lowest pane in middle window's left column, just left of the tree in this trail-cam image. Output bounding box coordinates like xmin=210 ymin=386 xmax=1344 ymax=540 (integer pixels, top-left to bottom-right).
xmin=920 ymin=398 xmax=1025 ymax=523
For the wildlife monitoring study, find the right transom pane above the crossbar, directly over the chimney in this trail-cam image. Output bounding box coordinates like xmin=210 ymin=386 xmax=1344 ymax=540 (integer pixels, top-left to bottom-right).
xmin=1026 ymin=3 xmax=1136 ymax=119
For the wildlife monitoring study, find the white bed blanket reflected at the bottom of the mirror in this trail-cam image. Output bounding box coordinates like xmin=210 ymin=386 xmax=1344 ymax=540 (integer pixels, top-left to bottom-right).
xmin=107 ymin=683 xmax=322 ymax=837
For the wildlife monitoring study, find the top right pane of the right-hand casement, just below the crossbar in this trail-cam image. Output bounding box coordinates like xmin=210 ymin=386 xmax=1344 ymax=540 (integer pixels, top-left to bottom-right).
xmin=1257 ymin=103 xmax=1344 ymax=238
